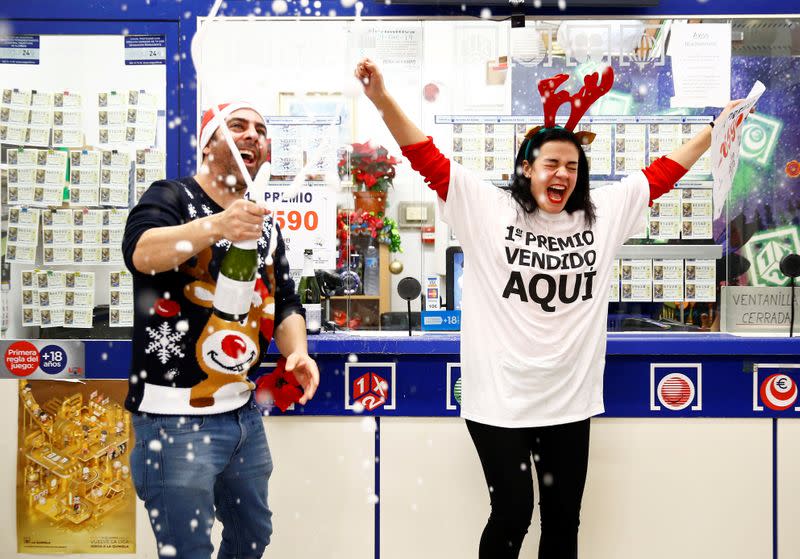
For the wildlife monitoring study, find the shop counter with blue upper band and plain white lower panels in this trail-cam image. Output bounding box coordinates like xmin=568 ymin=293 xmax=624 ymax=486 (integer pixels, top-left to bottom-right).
xmin=7 ymin=332 xmax=800 ymax=559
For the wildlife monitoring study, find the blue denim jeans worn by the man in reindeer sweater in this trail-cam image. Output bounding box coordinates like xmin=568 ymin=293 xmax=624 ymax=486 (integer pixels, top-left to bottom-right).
xmin=130 ymin=399 xmax=272 ymax=559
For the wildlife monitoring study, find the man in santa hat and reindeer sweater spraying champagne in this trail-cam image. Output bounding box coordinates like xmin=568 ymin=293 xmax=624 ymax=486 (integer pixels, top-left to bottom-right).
xmin=122 ymin=103 xmax=319 ymax=559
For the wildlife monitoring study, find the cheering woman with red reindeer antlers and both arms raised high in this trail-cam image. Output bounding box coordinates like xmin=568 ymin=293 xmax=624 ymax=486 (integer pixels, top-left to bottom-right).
xmin=355 ymin=59 xmax=752 ymax=559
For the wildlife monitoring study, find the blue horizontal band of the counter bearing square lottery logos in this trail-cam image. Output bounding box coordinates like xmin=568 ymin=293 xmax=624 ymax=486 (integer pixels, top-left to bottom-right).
xmin=76 ymin=332 xmax=800 ymax=417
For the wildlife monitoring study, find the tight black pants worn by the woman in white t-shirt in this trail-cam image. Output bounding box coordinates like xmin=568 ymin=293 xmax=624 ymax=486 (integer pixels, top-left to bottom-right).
xmin=467 ymin=419 xmax=589 ymax=559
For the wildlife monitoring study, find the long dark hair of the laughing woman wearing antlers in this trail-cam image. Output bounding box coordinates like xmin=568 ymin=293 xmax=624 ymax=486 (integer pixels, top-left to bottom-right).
xmin=503 ymin=127 xmax=595 ymax=226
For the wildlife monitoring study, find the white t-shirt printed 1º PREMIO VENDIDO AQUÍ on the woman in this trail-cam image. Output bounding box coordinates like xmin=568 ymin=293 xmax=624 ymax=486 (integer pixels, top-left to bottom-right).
xmin=439 ymin=162 xmax=650 ymax=427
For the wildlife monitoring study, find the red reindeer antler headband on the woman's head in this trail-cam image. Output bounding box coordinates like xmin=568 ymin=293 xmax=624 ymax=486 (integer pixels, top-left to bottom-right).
xmin=525 ymin=66 xmax=614 ymax=161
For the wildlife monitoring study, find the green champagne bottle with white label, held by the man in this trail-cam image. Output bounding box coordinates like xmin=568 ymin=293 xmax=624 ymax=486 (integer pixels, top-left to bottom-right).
xmin=214 ymin=240 xmax=258 ymax=321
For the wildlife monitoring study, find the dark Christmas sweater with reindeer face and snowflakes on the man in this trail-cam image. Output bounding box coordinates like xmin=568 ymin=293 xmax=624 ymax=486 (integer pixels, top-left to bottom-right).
xmin=122 ymin=177 xmax=303 ymax=415
